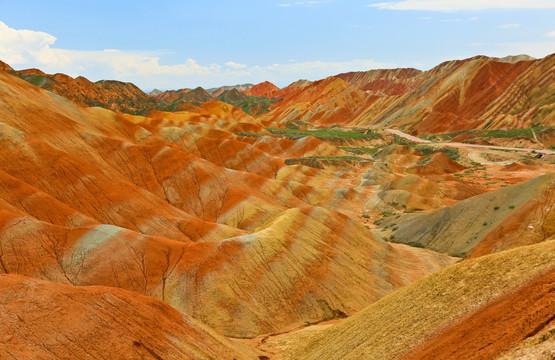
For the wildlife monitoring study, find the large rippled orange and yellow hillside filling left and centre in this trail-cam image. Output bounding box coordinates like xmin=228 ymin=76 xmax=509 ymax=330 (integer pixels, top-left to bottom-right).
xmin=0 ymin=62 xmax=457 ymax=337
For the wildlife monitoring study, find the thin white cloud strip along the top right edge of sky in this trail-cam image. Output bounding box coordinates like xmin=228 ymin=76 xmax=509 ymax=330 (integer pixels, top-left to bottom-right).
xmin=368 ymin=0 xmax=555 ymax=11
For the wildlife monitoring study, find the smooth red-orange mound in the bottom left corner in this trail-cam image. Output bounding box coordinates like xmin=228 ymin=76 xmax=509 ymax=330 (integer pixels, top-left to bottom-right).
xmin=0 ymin=274 xmax=257 ymax=360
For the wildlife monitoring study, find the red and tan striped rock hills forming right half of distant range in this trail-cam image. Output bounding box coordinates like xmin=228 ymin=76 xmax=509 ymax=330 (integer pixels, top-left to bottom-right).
xmin=264 ymin=54 xmax=555 ymax=134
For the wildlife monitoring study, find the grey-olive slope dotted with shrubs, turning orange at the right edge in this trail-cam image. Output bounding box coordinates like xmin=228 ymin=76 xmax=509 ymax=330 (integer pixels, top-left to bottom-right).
xmin=386 ymin=174 xmax=555 ymax=257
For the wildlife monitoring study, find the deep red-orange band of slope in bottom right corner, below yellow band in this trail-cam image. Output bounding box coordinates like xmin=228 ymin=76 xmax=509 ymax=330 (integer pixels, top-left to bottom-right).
xmin=400 ymin=269 xmax=555 ymax=360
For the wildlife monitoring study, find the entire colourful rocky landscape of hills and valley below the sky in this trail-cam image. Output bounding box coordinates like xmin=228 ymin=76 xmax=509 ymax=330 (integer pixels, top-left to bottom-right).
xmin=0 ymin=52 xmax=555 ymax=359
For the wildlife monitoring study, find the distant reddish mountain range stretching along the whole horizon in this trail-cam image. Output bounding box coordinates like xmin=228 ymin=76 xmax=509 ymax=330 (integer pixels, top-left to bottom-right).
xmin=1 ymin=55 xmax=555 ymax=133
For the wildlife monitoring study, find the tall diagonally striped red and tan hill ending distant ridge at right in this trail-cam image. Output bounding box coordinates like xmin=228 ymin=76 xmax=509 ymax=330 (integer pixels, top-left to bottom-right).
xmin=367 ymin=55 xmax=555 ymax=133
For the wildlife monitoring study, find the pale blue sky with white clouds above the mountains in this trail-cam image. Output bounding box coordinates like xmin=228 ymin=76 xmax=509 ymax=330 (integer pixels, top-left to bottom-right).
xmin=0 ymin=0 xmax=555 ymax=91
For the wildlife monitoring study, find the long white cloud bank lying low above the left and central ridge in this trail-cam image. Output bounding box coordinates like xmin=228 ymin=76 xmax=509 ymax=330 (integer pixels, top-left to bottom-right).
xmin=0 ymin=22 xmax=393 ymax=89
